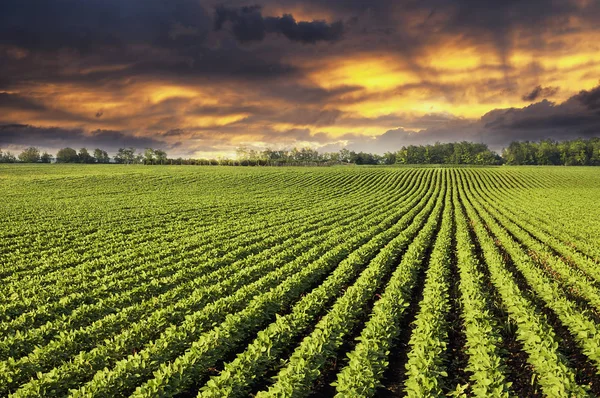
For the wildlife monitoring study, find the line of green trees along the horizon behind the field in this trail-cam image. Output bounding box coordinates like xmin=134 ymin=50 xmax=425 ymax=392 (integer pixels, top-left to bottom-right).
xmin=0 ymin=138 xmax=600 ymax=166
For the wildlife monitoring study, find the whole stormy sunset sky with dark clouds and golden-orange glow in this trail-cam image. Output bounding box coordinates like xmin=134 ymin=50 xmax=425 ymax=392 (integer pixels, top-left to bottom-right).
xmin=0 ymin=0 xmax=600 ymax=158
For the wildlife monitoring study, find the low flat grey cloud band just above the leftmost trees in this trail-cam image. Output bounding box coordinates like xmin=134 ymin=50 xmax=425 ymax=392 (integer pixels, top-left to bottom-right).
xmin=0 ymin=124 xmax=168 ymax=151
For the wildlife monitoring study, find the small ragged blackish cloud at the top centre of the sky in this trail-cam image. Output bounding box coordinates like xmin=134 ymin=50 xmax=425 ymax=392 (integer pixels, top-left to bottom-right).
xmin=214 ymin=5 xmax=344 ymax=44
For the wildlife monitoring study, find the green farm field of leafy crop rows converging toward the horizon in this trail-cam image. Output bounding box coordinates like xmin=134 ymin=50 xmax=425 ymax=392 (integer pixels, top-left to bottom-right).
xmin=0 ymin=165 xmax=600 ymax=397
